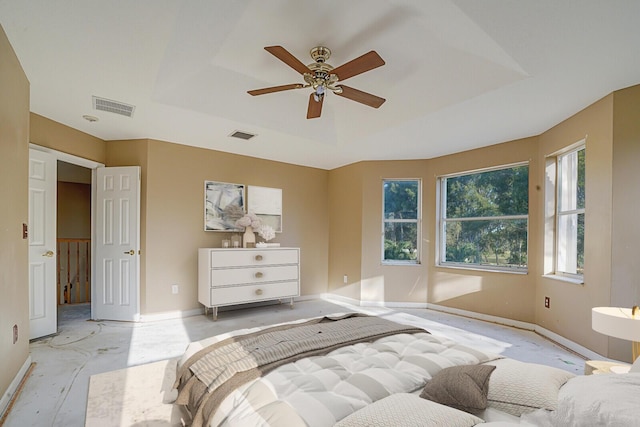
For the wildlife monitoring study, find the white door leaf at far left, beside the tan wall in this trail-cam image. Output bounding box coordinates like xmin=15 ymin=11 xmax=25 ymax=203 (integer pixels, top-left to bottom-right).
xmin=28 ymin=149 xmax=58 ymax=339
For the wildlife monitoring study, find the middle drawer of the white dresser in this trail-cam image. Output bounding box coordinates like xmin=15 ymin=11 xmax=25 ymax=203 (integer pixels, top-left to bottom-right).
xmin=211 ymin=265 xmax=298 ymax=286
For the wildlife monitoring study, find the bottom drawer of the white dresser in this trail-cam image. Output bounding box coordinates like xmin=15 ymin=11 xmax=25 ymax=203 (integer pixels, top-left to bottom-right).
xmin=211 ymin=281 xmax=298 ymax=306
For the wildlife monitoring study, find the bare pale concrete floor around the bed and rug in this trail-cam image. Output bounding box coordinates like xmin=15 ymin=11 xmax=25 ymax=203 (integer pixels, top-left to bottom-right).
xmin=5 ymin=300 xmax=584 ymax=427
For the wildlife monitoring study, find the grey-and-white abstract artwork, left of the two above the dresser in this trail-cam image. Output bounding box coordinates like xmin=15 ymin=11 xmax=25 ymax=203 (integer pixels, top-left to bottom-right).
xmin=204 ymin=181 xmax=245 ymax=231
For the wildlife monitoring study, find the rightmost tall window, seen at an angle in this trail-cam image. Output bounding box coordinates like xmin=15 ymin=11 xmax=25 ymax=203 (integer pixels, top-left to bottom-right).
xmin=556 ymin=145 xmax=585 ymax=278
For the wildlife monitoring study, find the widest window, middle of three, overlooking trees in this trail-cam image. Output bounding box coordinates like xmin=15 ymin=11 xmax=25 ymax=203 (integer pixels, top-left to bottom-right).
xmin=438 ymin=164 xmax=529 ymax=272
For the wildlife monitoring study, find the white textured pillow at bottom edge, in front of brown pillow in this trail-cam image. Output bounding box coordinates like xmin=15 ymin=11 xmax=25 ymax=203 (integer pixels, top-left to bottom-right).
xmin=334 ymin=393 xmax=484 ymax=427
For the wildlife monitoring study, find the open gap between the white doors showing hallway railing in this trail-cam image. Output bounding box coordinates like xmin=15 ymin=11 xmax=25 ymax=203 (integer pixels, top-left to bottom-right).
xmin=56 ymin=160 xmax=92 ymax=320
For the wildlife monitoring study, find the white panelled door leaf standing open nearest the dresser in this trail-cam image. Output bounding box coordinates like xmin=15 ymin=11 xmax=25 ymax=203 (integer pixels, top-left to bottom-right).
xmin=92 ymin=166 xmax=140 ymax=321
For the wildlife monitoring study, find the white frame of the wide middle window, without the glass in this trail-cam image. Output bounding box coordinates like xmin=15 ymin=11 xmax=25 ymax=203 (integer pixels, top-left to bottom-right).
xmin=436 ymin=161 xmax=531 ymax=274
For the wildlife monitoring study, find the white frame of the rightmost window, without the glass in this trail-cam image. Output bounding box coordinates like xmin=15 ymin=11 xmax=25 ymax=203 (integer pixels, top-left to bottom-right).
xmin=553 ymin=145 xmax=587 ymax=283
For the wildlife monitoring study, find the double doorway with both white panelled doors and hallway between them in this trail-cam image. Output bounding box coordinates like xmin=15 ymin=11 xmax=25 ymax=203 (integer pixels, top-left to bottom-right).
xmin=28 ymin=144 xmax=141 ymax=339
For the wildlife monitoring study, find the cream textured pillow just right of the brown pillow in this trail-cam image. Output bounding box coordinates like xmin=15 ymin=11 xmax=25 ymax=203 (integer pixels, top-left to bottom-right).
xmin=485 ymin=359 xmax=575 ymax=417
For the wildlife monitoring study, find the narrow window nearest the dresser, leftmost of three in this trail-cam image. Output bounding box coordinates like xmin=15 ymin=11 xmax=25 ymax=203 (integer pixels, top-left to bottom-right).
xmin=382 ymin=179 xmax=421 ymax=264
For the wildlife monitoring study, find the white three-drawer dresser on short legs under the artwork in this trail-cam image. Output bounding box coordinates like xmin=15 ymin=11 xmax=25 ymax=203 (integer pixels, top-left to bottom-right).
xmin=198 ymin=248 xmax=300 ymax=319
